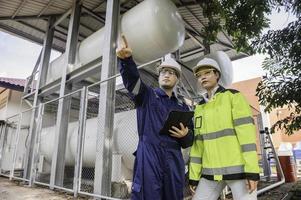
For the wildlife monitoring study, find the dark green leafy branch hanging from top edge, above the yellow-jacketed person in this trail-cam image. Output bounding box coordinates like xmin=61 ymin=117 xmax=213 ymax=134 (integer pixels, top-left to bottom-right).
xmin=197 ymin=0 xmax=272 ymax=54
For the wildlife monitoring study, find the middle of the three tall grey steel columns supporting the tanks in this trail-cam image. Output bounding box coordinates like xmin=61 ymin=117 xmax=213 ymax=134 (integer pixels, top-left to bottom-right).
xmin=50 ymin=0 xmax=81 ymax=189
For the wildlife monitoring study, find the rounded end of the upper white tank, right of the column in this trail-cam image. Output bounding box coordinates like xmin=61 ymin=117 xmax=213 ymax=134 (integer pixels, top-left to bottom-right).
xmin=121 ymin=0 xmax=185 ymax=63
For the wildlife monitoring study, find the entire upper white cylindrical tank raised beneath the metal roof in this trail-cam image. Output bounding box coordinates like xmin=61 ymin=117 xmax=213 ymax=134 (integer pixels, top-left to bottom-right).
xmin=47 ymin=0 xmax=185 ymax=83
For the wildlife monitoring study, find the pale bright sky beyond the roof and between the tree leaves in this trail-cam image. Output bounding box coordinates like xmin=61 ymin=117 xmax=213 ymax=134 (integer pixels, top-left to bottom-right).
xmin=0 ymin=8 xmax=295 ymax=82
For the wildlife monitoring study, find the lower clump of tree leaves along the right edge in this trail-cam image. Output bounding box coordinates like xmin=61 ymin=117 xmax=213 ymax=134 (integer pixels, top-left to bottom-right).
xmin=253 ymin=17 xmax=301 ymax=135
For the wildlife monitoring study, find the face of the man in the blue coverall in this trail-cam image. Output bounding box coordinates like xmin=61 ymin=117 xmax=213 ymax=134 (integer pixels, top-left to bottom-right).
xmin=159 ymin=67 xmax=178 ymax=89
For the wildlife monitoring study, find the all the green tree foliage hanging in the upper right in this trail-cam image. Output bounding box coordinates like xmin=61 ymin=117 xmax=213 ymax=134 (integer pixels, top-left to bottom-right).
xmin=197 ymin=0 xmax=301 ymax=134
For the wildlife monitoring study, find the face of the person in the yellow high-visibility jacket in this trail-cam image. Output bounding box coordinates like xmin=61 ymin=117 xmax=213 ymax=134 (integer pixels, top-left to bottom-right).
xmin=197 ymin=66 xmax=219 ymax=90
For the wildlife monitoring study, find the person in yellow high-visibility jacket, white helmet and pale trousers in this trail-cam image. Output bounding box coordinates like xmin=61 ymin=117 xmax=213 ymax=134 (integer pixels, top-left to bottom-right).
xmin=189 ymin=58 xmax=259 ymax=200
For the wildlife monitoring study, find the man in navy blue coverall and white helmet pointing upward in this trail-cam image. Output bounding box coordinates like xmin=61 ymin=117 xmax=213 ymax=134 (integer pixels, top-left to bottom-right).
xmin=116 ymin=36 xmax=193 ymax=200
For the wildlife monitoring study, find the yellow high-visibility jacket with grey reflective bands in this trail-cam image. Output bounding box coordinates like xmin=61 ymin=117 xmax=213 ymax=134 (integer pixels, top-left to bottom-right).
xmin=189 ymin=86 xmax=259 ymax=185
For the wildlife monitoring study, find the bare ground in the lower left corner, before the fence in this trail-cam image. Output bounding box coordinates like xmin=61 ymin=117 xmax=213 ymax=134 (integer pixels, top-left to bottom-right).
xmin=0 ymin=177 xmax=89 ymax=200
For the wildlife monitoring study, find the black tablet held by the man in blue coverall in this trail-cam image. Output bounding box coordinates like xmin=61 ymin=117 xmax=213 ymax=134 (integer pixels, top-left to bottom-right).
xmin=160 ymin=111 xmax=194 ymax=135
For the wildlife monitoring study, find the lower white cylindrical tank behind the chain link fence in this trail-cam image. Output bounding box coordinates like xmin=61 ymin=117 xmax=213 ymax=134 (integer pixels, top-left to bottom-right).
xmin=40 ymin=110 xmax=138 ymax=169
